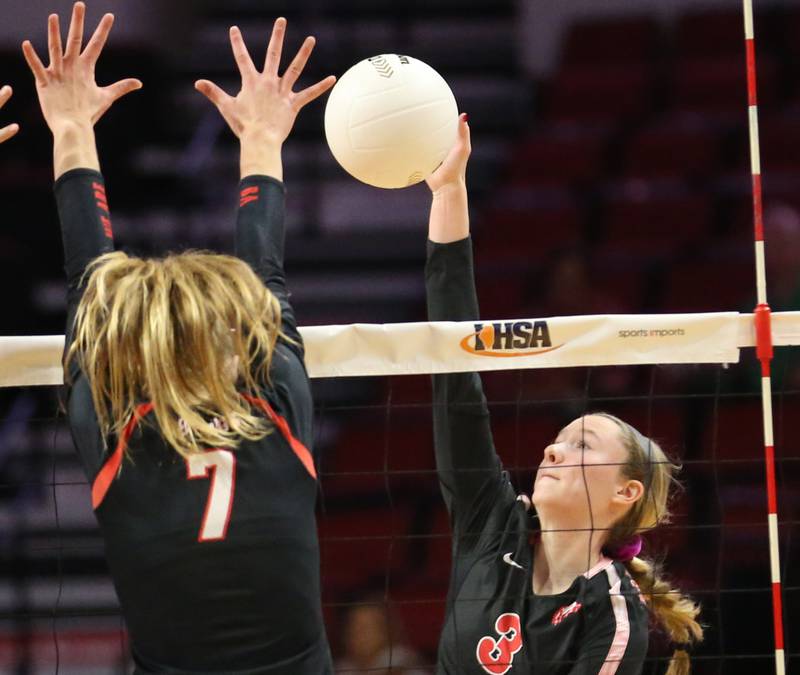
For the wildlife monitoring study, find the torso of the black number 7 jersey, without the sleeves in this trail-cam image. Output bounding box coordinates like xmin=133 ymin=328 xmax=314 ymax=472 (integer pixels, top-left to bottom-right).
xmin=71 ymin=368 xmax=327 ymax=674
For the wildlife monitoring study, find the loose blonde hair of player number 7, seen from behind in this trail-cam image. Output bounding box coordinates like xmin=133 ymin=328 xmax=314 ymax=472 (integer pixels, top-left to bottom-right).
xmin=65 ymin=251 xmax=281 ymax=457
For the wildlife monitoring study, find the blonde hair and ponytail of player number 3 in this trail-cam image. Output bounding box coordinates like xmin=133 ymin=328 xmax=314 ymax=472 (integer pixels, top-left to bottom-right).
xmin=592 ymin=413 xmax=703 ymax=675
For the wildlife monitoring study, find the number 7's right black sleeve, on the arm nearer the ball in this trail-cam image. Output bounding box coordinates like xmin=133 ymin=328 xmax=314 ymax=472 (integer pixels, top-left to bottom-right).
xmin=236 ymin=176 xmax=303 ymax=358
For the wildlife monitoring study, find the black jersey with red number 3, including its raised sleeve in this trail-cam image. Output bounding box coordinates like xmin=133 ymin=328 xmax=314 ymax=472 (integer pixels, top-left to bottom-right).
xmin=426 ymin=238 xmax=648 ymax=675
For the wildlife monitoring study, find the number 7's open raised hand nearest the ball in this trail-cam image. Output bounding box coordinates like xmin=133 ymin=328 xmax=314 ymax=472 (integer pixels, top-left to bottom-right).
xmin=195 ymin=18 xmax=336 ymax=145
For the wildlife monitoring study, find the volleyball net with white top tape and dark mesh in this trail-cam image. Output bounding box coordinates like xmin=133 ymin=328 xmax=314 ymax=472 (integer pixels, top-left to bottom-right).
xmin=0 ymin=312 xmax=800 ymax=675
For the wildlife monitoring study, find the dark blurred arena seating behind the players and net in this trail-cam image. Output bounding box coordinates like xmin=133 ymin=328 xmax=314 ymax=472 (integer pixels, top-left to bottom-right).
xmin=0 ymin=0 xmax=800 ymax=675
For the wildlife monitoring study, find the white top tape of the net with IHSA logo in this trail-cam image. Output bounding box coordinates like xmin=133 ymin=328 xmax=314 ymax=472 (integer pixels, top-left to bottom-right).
xmin=0 ymin=312 xmax=800 ymax=387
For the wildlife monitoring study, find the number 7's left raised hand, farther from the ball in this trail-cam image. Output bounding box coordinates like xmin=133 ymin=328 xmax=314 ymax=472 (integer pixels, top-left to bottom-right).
xmin=22 ymin=2 xmax=142 ymax=134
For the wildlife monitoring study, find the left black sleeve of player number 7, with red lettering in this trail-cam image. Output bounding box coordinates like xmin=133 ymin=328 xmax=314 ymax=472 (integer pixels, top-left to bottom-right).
xmin=54 ymin=169 xmax=114 ymax=381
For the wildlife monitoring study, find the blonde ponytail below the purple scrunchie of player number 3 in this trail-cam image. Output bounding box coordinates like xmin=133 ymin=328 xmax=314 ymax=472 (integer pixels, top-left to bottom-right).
xmin=625 ymin=558 xmax=703 ymax=675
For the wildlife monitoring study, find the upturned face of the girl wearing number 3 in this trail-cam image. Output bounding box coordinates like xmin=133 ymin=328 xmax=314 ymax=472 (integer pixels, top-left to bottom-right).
xmin=531 ymin=415 xmax=643 ymax=529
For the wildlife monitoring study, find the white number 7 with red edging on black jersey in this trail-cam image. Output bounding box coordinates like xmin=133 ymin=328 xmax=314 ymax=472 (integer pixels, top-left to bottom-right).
xmin=186 ymin=449 xmax=236 ymax=541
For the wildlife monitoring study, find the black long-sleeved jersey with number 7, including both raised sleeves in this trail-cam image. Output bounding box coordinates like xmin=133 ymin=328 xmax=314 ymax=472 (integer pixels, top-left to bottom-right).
xmin=55 ymin=170 xmax=332 ymax=675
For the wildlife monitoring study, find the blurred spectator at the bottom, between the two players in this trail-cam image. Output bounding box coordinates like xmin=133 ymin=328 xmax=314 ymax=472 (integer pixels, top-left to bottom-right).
xmin=335 ymin=595 xmax=429 ymax=675
